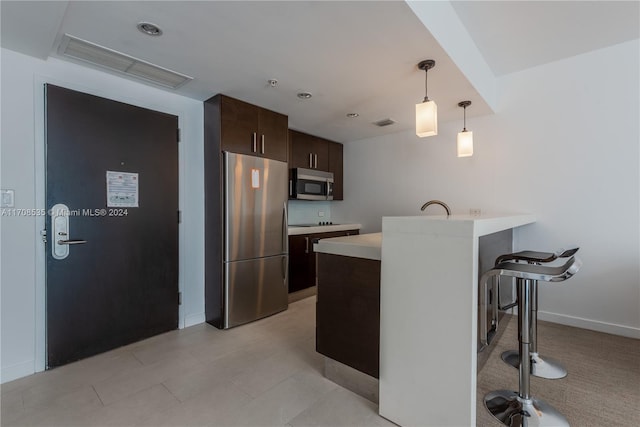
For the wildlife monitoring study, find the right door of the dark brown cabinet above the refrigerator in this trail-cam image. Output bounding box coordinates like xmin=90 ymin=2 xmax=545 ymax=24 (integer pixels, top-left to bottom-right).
xmin=258 ymin=108 xmax=289 ymax=162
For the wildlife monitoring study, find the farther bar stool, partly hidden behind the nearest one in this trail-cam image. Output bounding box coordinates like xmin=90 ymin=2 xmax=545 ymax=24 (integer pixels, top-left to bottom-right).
xmin=496 ymin=248 xmax=580 ymax=380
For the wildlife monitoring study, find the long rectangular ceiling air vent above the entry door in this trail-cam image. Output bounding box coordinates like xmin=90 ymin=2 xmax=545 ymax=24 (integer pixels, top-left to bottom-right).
xmin=58 ymin=34 xmax=193 ymax=89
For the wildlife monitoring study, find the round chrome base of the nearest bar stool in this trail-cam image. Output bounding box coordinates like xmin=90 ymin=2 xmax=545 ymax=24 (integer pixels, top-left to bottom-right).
xmin=484 ymin=390 xmax=569 ymax=427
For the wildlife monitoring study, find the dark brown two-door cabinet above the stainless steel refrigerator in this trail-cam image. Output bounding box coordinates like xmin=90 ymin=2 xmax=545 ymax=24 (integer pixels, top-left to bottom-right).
xmin=205 ymin=95 xmax=289 ymax=162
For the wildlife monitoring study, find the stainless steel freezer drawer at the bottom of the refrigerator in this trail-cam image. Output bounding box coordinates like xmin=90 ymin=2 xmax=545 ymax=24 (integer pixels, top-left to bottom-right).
xmin=224 ymin=255 xmax=289 ymax=329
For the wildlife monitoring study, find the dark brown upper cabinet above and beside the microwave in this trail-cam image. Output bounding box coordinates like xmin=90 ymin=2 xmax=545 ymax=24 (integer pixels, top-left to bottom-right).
xmin=289 ymin=129 xmax=343 ymax=200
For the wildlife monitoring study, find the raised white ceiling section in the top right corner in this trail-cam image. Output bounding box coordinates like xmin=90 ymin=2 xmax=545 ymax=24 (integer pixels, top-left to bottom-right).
xmin=451 ymin=0 xmax=640 ymax=76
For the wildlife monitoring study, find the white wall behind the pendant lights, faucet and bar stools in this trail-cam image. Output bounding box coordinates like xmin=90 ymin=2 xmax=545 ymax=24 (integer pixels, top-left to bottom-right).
xmin=332 ymin=40 xmax=640 ymax=338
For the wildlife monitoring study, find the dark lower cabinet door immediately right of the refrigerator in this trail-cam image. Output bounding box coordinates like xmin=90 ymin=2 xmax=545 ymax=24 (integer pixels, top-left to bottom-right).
xmin=289 ymin=234 xmax=316 ymax=293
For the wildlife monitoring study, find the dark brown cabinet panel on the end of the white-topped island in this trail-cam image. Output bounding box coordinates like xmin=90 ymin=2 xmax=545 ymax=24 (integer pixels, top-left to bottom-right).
xmin=316 ymin=253 xmax=380 ymax=378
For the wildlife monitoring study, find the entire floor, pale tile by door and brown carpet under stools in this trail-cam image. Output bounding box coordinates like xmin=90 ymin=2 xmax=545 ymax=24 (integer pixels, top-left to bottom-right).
xmin=0 ymin=297 xmax=640 ymax=427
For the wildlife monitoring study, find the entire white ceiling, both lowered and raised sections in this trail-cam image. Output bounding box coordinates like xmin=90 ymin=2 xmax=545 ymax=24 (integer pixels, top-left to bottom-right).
xmin=0 ymin=0 xmax=640 ymax=142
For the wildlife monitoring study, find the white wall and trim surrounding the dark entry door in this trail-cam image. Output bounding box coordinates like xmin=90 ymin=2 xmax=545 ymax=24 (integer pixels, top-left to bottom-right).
xmin=0 ymin=49 xmax=204 ymax=382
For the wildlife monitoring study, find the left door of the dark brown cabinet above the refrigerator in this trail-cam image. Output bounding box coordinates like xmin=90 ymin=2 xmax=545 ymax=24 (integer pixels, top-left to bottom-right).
xmin=220 ymin=96 xmax=260 ymax=155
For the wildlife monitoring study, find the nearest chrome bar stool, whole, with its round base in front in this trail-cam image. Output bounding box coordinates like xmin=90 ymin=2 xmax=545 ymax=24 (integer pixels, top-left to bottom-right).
xmin=481 ymin=256 xmax=582 ymax=426
